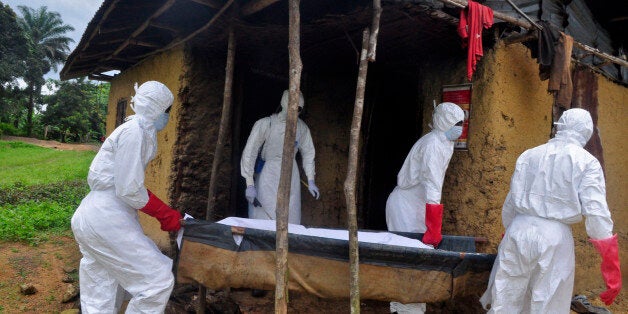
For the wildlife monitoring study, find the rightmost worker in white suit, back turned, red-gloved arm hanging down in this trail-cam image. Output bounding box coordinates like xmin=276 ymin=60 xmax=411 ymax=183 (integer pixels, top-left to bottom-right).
xmin=480 ymin=109 xmax=621 ymax=313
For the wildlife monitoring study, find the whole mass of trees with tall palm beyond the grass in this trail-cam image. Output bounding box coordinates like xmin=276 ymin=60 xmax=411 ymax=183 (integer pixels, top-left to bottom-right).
xmin=0 ymin=4 xmax=109 ymax=141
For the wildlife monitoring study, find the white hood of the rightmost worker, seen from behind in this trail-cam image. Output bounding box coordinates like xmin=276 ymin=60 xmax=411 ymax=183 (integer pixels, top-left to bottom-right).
xmin=554 ymin=108 xmax=593 ymax=147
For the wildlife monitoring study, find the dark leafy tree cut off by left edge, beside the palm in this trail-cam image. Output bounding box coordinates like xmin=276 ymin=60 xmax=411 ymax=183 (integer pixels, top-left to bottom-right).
xmin=0 ymin=2 xmax=28 ymax=86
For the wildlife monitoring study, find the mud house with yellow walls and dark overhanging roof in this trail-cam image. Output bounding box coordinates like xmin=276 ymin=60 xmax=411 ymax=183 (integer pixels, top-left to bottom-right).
xmin=61 ymin=0 xmax=628 ymax=310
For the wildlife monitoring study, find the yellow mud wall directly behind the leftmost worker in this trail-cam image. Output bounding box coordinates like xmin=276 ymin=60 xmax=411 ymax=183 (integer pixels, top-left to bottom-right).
xmin=106 ymin=48 xmax=184 ymax=251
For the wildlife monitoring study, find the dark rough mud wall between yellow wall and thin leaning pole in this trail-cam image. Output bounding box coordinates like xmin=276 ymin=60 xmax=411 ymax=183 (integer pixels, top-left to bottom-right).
xmin=170 ymin=48 xmax=235 ymax=220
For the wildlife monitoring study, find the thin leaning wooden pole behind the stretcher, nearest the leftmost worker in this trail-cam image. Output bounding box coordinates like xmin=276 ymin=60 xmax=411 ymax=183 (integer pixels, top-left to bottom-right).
xmin=196 ymin=25 xmax=236 ymax=313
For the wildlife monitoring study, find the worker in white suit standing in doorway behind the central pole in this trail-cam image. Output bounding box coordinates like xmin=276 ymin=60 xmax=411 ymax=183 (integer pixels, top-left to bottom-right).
xmin=240 ymin=90 xmax=320 ymax=224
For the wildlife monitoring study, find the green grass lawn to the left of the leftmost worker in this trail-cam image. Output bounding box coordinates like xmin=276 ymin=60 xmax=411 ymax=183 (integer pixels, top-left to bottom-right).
xmin=0 ymin=141 xmax=95 ymax=245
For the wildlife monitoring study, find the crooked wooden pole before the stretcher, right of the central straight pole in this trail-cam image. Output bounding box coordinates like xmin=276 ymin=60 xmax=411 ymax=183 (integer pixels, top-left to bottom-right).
xmin=344 ymin=28 xmax=370 ymax=314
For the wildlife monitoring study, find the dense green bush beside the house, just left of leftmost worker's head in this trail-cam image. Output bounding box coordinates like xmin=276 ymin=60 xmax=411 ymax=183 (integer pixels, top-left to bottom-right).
xmin=42 ymin=79 xmax=109 ymax=142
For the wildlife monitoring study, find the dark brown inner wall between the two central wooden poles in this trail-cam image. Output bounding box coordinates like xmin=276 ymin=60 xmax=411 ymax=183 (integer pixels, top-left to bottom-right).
xmin=300 ymin=73 xmax=356 ymax=228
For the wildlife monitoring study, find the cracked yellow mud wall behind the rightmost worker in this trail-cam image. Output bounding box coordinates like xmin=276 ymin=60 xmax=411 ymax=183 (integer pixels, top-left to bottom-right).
xmin=434 ymin=41 xmax=628 ymax=311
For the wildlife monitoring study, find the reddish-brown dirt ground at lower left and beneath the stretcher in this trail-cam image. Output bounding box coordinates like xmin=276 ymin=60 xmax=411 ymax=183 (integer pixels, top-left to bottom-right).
xmin=0 ymin=237 xmax=388 ymax=314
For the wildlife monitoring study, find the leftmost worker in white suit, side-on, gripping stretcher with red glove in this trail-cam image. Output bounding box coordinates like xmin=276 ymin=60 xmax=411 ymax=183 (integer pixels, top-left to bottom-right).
xmin=72 ymin=81 xmax=181 ymax=313
